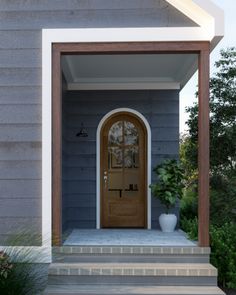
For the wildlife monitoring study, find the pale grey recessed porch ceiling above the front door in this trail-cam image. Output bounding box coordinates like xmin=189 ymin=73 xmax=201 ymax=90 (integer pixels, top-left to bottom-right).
xmin=62 ymin=54 xmax=198 ymax=90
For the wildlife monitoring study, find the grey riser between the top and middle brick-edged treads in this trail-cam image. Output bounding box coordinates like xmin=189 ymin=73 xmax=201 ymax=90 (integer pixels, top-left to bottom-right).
xmin=53 ymin=254 xmax=209 ymax=263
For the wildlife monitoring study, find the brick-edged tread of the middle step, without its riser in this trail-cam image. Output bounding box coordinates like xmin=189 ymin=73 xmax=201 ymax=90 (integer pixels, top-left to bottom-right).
xmin=49 ymin=262 xmax=217 ymax=276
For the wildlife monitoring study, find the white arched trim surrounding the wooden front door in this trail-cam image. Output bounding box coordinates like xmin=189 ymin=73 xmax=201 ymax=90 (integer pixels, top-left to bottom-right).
xmin=96 ymin=108 xmax=152 ymax=229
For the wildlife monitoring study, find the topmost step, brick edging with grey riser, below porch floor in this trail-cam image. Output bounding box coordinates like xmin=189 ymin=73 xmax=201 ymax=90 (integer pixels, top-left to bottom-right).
xmin=53 ymin=246 xmax=210 ymax=263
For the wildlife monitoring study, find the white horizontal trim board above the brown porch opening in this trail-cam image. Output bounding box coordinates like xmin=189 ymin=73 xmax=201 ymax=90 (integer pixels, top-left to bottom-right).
xmin=43 ymin=27 xmax=214 ymax=43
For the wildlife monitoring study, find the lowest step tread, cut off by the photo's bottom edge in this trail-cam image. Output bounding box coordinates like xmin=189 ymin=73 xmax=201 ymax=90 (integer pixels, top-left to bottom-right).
xmin=44 ymin=285 xmax=225 ymax=295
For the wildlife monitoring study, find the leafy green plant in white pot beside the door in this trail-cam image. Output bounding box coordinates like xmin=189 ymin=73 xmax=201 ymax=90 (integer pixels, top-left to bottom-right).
xmin=150 ymin=159 xmax=184 ymax=232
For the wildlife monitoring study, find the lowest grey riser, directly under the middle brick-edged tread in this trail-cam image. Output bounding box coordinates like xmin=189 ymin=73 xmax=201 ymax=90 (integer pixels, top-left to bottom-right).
xmin=48 ymin=275 xmax=217 ymax=286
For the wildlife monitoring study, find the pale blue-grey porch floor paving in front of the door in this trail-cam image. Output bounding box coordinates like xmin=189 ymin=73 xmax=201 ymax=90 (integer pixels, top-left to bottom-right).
xmin=64 ymin=229 xmax=197 ymax=246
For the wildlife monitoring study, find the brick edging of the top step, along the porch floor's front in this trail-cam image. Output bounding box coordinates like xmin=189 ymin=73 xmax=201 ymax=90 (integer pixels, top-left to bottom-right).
xmin=53 ymin=246 xmax=210 ymax=255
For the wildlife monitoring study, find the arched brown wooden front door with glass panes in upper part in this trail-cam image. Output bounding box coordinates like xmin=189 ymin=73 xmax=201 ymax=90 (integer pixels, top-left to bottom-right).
xmin=100 ymin=112 xmax=147 ymax=228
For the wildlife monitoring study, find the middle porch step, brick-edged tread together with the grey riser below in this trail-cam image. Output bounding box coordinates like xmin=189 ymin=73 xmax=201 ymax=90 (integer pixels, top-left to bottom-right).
xmin=49 ymin=263 xmax=217 ymax=286
